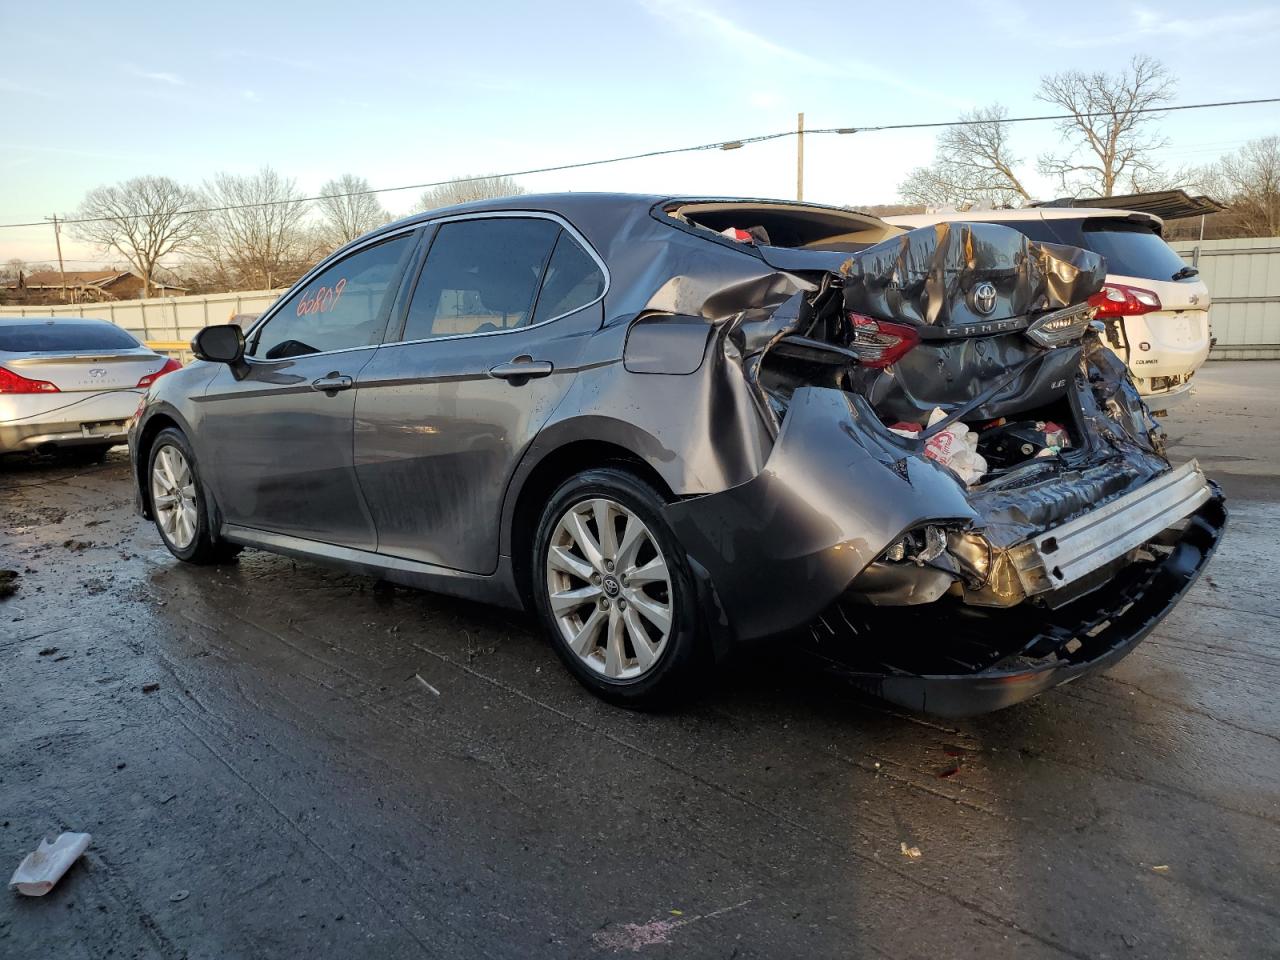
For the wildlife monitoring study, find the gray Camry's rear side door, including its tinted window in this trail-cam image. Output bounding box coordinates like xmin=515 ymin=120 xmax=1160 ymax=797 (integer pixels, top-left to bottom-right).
xmin=355 ymin=212 xmax=607 ymax=573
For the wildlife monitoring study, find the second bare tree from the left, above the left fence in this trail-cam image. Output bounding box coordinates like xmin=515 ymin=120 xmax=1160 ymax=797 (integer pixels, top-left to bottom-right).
xmin=200 ymin=166 xmax=314 ymax=289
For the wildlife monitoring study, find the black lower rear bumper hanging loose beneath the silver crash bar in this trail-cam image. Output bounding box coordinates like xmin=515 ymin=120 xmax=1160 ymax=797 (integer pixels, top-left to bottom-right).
xmin=806 ymin=486 xmax=1226 ymax=717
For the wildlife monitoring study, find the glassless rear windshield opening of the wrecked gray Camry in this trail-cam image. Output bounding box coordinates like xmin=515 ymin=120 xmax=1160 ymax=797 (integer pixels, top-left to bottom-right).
xmin=667 ymin=201 xmax=902 ymax=253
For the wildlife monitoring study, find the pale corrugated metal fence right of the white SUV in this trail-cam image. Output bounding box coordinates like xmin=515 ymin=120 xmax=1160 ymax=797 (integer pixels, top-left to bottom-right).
xmin=1172 ymin=237 xmax=1280 ymax=360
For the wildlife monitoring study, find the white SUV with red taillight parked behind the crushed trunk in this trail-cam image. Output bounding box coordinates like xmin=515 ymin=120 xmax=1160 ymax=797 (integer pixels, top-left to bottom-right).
xmin=884 ymin=206 xmax=1210 ymax=412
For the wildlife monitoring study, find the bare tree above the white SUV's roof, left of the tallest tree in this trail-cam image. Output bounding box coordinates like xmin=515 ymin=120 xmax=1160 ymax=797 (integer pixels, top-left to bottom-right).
xmin=897 ymin=104 xmax=1032 ymax=206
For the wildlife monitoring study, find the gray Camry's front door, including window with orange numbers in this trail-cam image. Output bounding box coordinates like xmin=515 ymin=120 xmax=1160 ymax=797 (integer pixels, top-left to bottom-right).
xmin=197 ymin=232 xmax=417 ymax=550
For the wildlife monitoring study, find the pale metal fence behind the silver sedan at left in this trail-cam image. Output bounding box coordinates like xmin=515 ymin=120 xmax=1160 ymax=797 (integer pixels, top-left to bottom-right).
xmin=0 ymin=289 xmax=284 ymax=353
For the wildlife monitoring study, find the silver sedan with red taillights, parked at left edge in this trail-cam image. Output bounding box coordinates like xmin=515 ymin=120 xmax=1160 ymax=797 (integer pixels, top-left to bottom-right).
xmin=0 ymin=316 xmax=178 ymax=461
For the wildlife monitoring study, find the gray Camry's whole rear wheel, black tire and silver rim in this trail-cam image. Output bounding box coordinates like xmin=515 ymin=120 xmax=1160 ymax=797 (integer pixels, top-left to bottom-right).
xmin=534 ymin=467 xmax=705 ymax=707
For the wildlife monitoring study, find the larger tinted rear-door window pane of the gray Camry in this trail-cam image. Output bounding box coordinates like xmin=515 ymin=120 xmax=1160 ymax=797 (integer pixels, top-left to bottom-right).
xmin=404 ymin=216 xmax=561 ymax=340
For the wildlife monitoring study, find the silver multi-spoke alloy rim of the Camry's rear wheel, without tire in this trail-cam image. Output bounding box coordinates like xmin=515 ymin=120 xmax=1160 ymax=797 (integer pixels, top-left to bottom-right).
xmin=547 ymin=498 xmax=673 ymax=680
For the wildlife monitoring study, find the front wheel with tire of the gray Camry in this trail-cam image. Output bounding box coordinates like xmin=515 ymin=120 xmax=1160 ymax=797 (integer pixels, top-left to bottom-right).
xmin=147 ymin=428 xmax=241 ymax=563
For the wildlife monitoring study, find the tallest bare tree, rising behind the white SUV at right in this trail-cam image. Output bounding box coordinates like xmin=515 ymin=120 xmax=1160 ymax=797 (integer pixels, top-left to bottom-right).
xmin=1036 ymin=55 xmax=1175 ymax=197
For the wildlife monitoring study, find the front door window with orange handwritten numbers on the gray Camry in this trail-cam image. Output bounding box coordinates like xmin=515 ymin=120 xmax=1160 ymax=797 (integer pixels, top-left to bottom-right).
xmin=248 ymin=234 xmax=413 ymax=360
